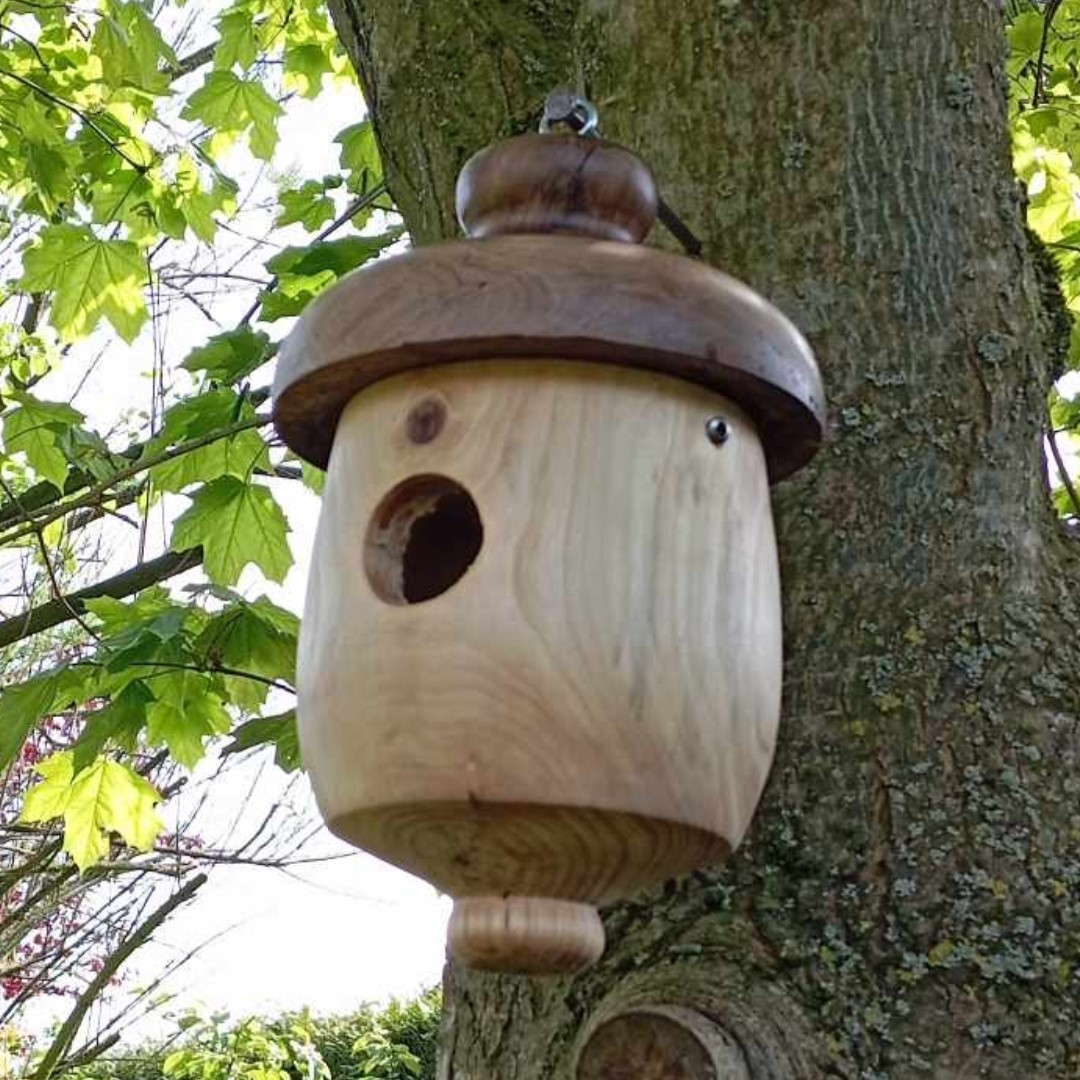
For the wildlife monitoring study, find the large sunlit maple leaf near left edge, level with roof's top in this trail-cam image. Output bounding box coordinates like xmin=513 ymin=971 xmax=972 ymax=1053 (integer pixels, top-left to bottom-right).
xmin=18 ymin=225 xmax=147 ymax=341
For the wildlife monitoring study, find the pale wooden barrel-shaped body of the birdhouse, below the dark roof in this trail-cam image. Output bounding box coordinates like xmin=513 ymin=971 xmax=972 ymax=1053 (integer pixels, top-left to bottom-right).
xmin=299 ymin=360 xmax=781 ymax=968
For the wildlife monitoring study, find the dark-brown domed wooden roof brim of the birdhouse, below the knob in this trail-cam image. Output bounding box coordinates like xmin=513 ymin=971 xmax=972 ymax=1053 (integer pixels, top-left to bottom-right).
xmin=273 ymin=235 xmax=825 ymax=481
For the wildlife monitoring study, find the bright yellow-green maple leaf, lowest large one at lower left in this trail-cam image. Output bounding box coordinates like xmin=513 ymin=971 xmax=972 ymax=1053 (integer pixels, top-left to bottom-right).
xmin=19 ymin=751 xmax=164 ymax=870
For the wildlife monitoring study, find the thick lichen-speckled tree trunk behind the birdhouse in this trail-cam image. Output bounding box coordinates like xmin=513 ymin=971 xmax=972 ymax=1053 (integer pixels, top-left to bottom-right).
xmin=332 ymin=0 xmax=1080 ymax=1080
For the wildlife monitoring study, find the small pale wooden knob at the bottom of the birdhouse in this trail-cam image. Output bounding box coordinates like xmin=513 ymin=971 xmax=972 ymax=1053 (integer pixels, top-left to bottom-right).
xmin=448 ymin=896 xmax=604 ymax=975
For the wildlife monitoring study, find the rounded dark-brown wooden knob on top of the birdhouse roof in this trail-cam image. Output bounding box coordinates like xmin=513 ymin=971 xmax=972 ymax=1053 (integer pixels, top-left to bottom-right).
xmin=457 ymin=135 xmax=657 ymax=243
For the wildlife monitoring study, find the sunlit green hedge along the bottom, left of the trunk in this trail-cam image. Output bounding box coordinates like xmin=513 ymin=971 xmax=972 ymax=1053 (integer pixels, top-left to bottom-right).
xmin=68 ymin=989 xmax=442 ymax=1080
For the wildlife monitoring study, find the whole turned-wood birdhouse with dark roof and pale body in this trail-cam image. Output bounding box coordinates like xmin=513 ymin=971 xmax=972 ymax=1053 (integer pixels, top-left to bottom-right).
xmin=274 ymin=122 xmax=823 ymax=973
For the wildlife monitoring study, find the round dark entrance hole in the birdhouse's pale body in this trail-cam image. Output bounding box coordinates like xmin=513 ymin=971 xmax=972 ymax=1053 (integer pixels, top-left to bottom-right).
xmin=364 ymin=475 xmax=484 ymax=605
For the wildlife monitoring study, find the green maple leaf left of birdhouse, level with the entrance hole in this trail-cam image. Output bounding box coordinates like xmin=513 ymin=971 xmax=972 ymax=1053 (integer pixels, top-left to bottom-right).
xmin=171 ymin=476 xmax=293 ymax=585
